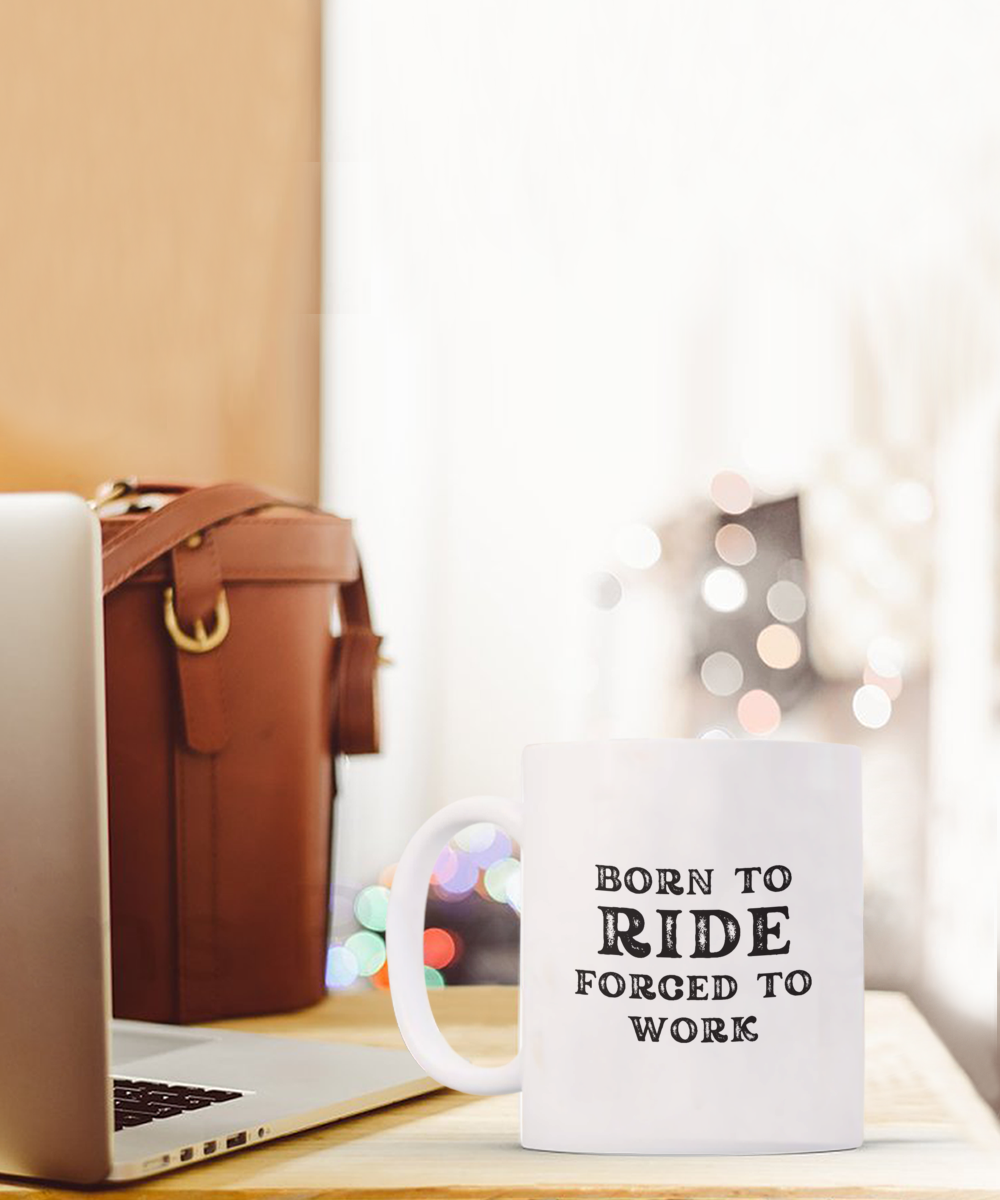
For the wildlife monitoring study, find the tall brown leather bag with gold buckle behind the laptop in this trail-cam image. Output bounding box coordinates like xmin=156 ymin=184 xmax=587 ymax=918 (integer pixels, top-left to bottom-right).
xmin=97 ymin=481 xmax=381 ymax=1021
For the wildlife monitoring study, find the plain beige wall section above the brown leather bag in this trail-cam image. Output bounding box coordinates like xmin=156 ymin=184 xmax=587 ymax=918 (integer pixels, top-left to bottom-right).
xmin=0 ymin=0 xmax=321 ymax=497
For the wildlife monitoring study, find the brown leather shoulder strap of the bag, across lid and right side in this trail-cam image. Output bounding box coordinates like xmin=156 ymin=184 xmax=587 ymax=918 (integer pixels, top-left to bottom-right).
xmin=95 ymin=480 xmax=382 ymax=754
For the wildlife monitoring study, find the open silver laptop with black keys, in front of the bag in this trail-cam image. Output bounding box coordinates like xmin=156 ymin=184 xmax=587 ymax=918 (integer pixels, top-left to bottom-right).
xmin=0 ymin=494 xmax=437 ymax=1183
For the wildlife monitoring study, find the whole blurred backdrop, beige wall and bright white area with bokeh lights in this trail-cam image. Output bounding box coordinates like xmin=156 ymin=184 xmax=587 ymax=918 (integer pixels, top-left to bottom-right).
xmin=0 ymin=0 xmax=1000 ymax=1106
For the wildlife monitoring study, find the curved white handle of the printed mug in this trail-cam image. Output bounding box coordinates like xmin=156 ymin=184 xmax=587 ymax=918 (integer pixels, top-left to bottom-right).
xmin=385 ymin=796 xmax=522 ymax=1096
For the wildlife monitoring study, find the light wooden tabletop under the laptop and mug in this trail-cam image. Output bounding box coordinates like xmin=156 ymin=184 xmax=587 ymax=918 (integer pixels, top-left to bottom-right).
xmin=0 ymin=988 xmax=1000 ymax=1200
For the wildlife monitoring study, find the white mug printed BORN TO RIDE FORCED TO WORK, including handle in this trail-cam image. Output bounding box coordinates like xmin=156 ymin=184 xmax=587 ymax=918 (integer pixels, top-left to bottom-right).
xmin=387 ymin=740 xmax=864 ymax=1154
